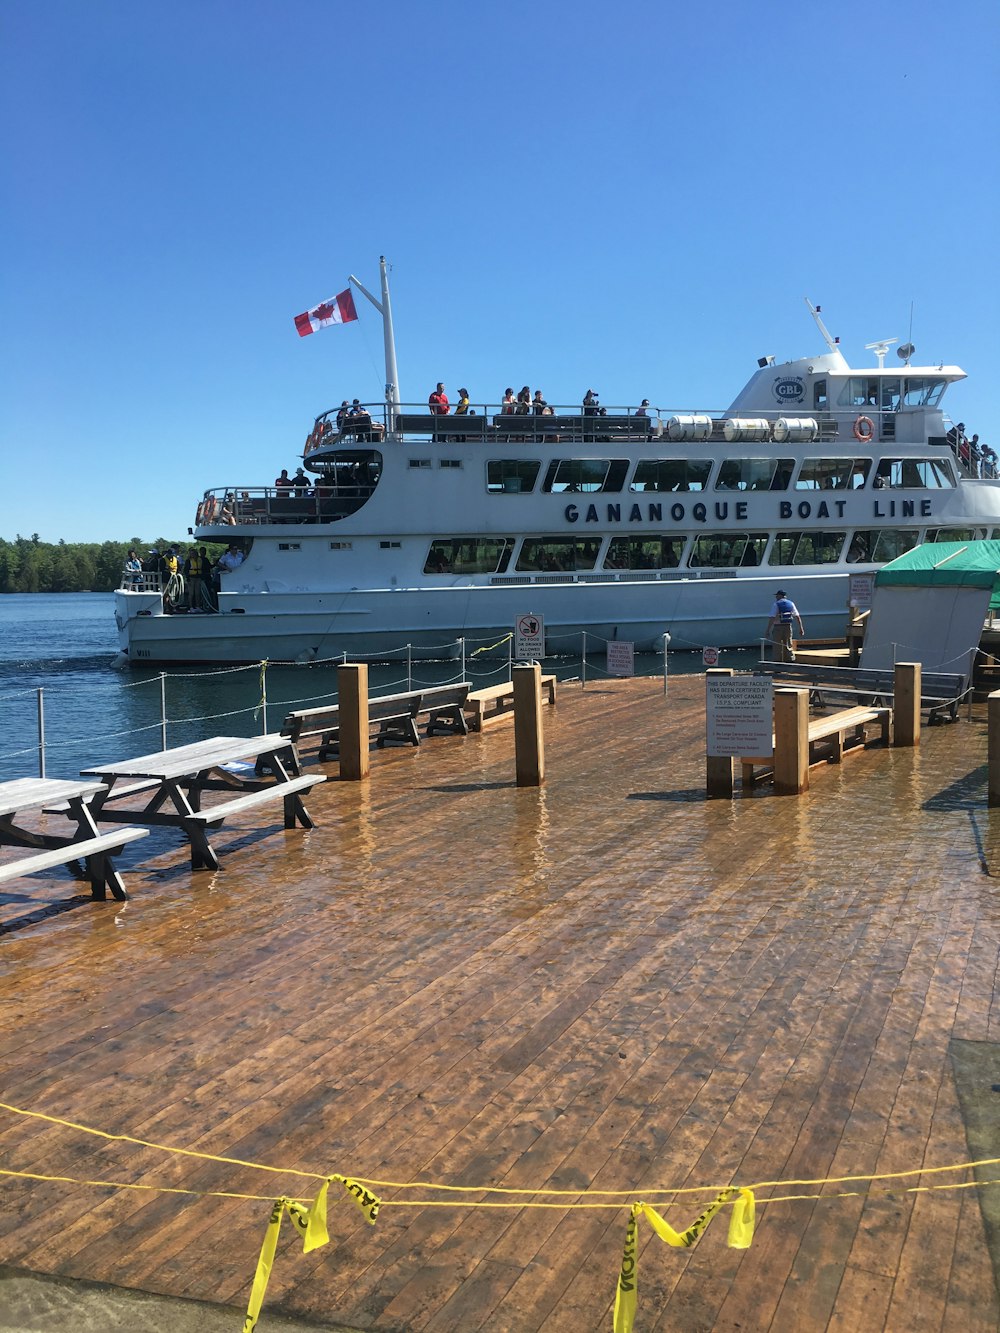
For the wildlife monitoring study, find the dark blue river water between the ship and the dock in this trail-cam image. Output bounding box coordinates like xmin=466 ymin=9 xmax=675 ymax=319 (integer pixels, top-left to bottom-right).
xmin=0 ymin=593 xmax=751 ymax=778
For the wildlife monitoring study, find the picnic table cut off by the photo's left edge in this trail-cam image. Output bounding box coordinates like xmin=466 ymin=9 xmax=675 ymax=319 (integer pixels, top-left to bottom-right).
xmin=0 ymin=777 xmax=149 ymax=901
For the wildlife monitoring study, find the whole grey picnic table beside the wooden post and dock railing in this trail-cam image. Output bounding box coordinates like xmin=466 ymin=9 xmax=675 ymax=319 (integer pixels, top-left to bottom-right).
xmin=84 ymin=733 xmax=325 ymax=870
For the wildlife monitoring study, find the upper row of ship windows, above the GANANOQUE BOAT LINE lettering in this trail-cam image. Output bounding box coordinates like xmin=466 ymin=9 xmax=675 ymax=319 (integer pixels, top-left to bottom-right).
xmin=409 ymin=457 xmax=955 ymax=495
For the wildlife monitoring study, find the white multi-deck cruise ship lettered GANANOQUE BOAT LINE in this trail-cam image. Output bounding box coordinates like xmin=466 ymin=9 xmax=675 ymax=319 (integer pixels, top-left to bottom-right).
xmin=116 ymin=261 xmax=1000 ymax=665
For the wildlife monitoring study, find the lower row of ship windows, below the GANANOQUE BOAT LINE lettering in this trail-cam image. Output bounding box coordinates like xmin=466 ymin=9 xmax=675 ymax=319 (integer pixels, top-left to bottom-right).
xmin=292 ymin=528 xmax=1000 ymax=575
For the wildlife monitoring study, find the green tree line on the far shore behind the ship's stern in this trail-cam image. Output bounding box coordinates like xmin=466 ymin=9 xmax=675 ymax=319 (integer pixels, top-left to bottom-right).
xmin=0 ymin=532 xmax=218 ymax=593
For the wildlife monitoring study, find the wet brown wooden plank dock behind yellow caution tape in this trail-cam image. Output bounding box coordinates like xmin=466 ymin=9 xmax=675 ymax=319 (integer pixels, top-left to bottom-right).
xmin=0 ymin=677 xmax=1000 ymax=1333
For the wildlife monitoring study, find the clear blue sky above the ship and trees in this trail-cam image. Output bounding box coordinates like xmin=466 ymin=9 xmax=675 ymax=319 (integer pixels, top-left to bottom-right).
xmin=0 ymin=0 xmax=1000 ymax=541
